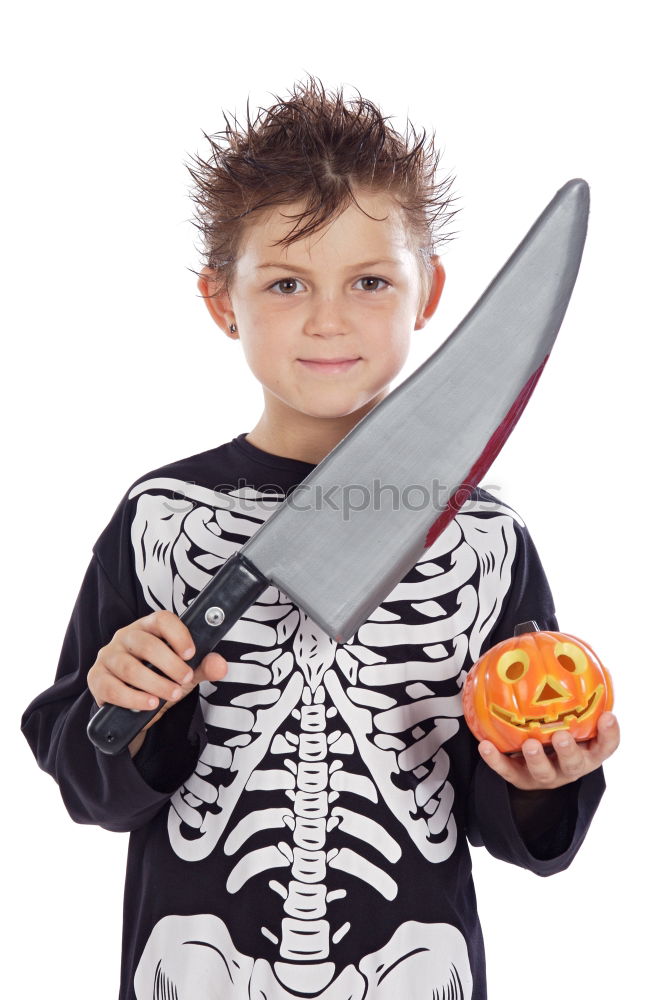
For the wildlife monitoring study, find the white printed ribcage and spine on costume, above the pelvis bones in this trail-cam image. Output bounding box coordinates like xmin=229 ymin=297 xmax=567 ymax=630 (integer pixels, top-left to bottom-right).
xmin=132 ymin=484 xmax=515 ymax=961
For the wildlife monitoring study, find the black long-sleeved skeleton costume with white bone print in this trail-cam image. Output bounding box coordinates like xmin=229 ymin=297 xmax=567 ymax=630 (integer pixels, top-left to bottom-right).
xmin=22 ymin=434 xmax=604 ymax=1000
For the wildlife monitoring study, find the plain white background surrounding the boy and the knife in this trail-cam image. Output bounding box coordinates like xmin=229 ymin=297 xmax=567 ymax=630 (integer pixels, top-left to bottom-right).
xmin=1 ymin=0 xmax=663 ymax=1000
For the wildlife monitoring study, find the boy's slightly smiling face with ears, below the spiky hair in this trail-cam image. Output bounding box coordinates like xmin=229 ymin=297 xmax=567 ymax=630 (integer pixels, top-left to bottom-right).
xmin=200 ymin=192 xmax=444 ymax=419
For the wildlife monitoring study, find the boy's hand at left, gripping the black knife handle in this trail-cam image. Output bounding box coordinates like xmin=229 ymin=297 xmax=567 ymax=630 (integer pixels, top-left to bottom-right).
xmin=88 ymin=610 xmax=228 ymax=730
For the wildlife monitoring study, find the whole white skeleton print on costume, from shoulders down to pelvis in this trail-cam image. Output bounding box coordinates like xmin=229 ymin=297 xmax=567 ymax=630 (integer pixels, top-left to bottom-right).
xmin=124 ymin=479 xmax=518 ymax=1000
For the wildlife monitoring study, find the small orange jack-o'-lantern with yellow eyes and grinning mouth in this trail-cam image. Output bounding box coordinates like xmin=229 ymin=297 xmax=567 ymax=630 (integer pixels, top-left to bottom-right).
xmin=463 ymin=622 xmax=613 ymax=753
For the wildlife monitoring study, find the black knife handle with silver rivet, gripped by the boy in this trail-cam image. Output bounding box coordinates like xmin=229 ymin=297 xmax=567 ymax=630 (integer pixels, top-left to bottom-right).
xmin=87 ymin=552 xmax=270 ymax=756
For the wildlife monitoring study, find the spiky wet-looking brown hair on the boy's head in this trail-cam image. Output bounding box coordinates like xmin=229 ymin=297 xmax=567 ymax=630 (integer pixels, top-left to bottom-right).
xmin=187 ymin=74 xmax=456 ymax=290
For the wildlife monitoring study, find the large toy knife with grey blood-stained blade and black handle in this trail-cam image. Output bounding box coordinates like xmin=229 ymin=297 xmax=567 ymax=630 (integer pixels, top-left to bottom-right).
xmin=88 ymin=179 xmax=589 ymax=754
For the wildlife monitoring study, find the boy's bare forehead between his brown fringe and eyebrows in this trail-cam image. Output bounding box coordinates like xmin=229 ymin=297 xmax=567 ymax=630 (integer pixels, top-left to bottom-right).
xmin=238 ymin=191 xmax=410 ymax=267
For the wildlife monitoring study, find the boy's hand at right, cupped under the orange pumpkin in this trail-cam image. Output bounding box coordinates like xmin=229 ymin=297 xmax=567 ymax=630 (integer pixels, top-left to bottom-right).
xmin=479 ymin=712 xmax=620 ymax=791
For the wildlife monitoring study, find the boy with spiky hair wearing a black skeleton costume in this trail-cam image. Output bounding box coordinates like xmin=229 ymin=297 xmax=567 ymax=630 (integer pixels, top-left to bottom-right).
xmin=23 ymin=79 xmax=618 ymax=1000
